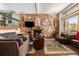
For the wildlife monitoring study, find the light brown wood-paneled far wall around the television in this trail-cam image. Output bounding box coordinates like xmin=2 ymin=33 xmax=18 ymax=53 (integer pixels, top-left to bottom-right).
xmin=20 ymin=14 xmax=59 ymax=37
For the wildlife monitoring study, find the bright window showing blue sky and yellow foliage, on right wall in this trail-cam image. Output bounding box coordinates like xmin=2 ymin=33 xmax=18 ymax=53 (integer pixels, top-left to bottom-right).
xmin=65 ymin=16 xmax=79 ymax=33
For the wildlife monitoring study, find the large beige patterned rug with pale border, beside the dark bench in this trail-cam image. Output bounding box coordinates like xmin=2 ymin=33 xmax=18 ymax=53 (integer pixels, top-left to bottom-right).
xmin=44 ymin=40 xmax=76 ymax=54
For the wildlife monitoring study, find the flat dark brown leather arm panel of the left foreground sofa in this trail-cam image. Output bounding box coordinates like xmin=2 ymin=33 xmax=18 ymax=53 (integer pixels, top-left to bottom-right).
xmin=0 ymin=41 xmax=19 ymax=56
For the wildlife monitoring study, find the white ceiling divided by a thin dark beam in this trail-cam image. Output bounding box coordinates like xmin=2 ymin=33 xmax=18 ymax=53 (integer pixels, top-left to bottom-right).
xmin=4 ymin=3 xmax=70 ymax=13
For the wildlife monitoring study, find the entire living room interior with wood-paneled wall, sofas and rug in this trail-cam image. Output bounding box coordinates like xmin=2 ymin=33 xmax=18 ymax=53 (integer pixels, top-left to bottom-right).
xmin=0 ymin=3 xmax=79 ymax=56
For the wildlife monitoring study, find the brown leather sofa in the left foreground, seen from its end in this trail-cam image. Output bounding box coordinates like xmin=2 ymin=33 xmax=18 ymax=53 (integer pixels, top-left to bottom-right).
xmin=0 ymin=33 xmax=29 ymax=56
